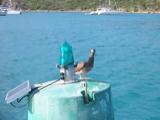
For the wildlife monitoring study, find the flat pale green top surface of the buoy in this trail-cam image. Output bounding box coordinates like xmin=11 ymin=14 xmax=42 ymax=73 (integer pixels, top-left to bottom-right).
xmin=35 ymin=81 xmax=110 ymax=97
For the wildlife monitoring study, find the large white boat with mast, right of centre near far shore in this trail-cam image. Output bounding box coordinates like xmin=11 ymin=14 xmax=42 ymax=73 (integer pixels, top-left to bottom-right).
xmin=89 ymin=0 xmax=125 ymax=15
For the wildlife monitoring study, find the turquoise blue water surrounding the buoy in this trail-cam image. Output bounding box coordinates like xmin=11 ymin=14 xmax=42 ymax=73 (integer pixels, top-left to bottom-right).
xmin=0 ymin=13 xmax=160 ymax=120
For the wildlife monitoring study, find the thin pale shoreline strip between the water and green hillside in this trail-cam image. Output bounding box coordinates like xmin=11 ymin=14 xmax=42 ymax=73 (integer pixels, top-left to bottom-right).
xmin=23 ymin=10 xmax=160 ymax=14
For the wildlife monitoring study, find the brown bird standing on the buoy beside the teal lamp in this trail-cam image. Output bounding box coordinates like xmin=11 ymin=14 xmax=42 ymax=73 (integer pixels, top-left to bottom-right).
xmin=75 ymin=49 xmax=96 ymax=79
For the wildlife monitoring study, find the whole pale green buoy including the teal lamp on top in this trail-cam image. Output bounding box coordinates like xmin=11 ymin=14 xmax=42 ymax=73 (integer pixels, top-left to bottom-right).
xmin=28 ymin=42 xmax=114 ymax=120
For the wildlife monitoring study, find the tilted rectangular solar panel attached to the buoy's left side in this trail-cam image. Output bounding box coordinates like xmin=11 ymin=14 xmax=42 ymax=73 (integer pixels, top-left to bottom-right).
xmin=5 ymin=80 xmax=31 ymax=104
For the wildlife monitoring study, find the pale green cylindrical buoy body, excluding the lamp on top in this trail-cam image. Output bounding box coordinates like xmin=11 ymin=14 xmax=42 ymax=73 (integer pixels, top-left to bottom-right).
xmin=28 ymin=81 xmax=114 ymax=120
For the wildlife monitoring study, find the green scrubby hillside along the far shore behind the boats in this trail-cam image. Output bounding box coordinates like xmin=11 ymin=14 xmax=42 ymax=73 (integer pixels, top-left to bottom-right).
xmin=0 ymin=0 xmax=160 ymax=12
